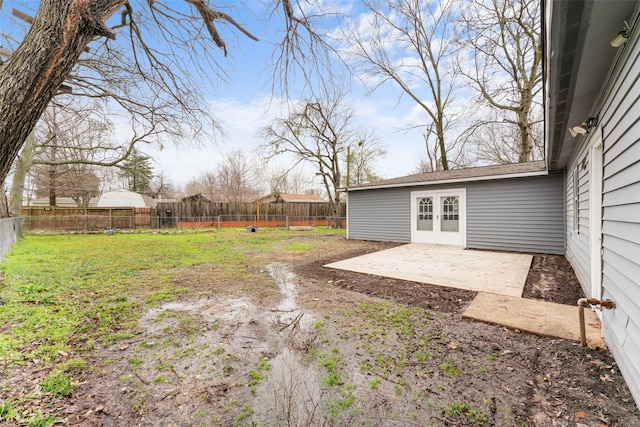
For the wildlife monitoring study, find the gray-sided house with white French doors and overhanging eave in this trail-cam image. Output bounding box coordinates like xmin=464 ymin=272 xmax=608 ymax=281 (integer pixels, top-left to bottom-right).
xmin=345 ymin=0 xmax=640 ymax=405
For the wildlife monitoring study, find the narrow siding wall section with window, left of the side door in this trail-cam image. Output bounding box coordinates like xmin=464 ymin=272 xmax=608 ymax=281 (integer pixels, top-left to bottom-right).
xmin=566 ymin=141 xmax=591 ymax=295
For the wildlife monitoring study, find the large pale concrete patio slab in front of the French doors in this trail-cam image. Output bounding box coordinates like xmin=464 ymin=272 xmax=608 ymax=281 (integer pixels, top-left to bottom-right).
xmin=325 ymin=243 xmax=533 ymax=297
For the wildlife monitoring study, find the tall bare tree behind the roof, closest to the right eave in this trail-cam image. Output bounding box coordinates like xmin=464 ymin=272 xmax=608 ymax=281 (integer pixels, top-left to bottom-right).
xmin=459 ymin=0 xmax=542 ymax=163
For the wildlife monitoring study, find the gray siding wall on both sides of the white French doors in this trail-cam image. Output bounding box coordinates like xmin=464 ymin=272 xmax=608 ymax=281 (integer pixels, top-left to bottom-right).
xmin=347 ymin=174 xmax=565 ymax=254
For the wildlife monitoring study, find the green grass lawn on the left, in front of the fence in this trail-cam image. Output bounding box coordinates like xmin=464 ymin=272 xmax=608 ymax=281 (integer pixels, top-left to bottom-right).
xmin=0 ymin=229 xmax=344 ymax=363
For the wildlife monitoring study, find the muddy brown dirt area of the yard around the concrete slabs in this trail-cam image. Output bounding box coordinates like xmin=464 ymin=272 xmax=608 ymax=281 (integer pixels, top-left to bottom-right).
xmin=4 ymin=236 xmax=640 ymax=427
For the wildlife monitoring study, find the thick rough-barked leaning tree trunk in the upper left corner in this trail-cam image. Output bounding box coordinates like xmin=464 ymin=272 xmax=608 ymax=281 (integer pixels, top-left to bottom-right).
xmin=0 ymin=0 xmax=125 ymax=183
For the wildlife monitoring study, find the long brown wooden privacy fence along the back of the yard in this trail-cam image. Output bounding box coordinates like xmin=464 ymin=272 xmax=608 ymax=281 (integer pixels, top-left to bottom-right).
xmin=22 ymin=202 xmax=345 ymax=232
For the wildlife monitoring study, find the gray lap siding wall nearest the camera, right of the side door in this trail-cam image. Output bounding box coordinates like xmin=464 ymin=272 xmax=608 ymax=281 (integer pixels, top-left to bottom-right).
xmin=600 ymin=23 xmax=640 ymax=405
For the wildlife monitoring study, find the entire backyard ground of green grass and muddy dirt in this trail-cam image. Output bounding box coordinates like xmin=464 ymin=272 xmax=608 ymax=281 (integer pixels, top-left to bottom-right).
xmin=0 ymin=228 xmax=640 ymax=427
